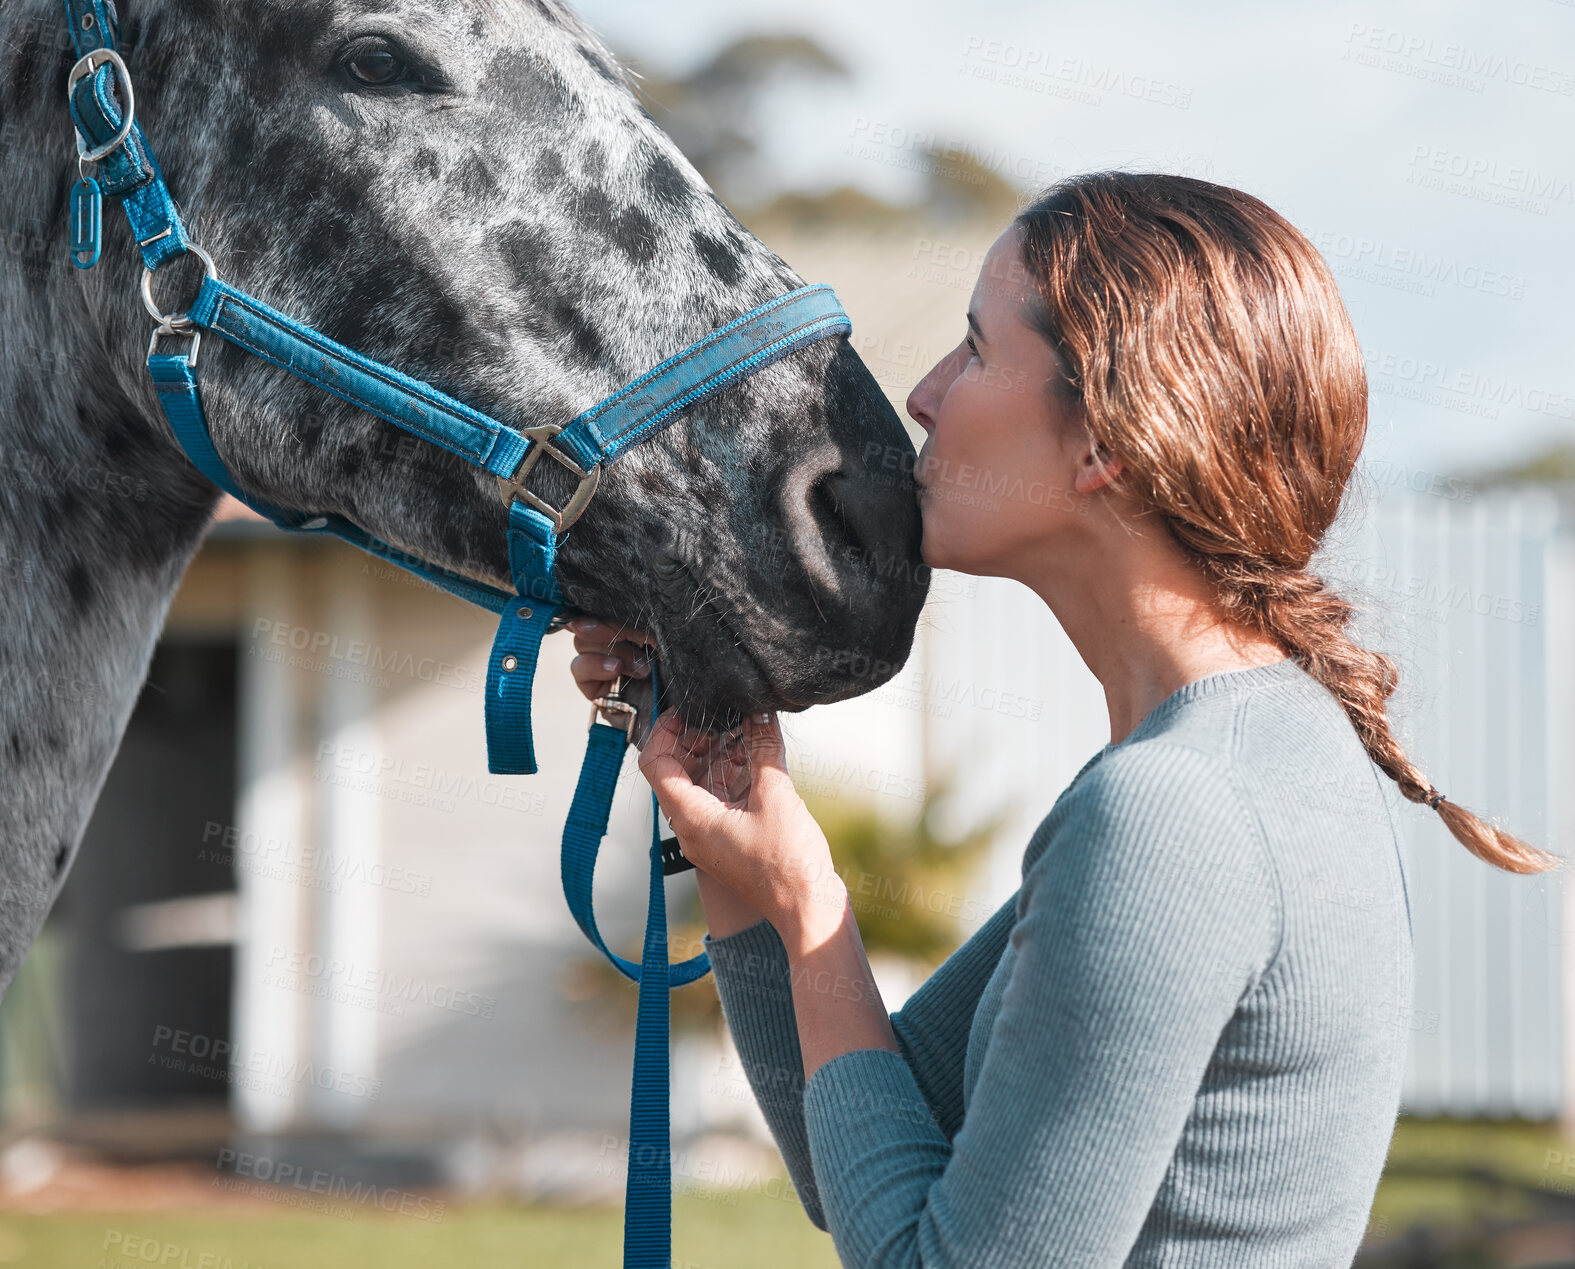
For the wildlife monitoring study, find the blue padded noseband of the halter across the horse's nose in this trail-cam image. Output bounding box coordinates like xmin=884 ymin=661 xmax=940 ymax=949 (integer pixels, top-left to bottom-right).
xmin=553 ymin=283 xmax=852 ymax=469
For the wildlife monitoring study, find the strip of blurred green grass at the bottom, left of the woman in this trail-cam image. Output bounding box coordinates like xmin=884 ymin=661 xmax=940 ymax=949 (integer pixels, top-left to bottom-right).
xmin=0 ymin=1193 xmax=838 ymax=1269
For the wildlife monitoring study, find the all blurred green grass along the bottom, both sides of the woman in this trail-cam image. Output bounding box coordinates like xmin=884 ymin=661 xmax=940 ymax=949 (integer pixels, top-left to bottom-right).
xmin=0 ymin=1118 xmax=1575 ymax=1269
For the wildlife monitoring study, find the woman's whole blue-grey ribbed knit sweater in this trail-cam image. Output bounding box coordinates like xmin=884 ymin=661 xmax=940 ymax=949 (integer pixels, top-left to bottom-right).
xmin=706 ymin=661 xmax=1411 ymax=1269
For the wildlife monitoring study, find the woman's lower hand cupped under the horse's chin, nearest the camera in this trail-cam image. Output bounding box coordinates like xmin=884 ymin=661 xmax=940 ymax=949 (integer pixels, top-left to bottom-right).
xmin=639 ymin=710 xmax=847 ymax=953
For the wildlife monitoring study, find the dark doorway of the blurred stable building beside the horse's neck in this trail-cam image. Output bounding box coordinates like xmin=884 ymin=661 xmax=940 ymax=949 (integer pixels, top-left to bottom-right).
xmin=60 ymin=638 xmax=238 ymax=1112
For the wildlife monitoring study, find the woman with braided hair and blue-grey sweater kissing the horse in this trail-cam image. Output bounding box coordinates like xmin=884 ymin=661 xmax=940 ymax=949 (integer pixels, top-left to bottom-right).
xmin=573 ymin=173 xmax=1555 ymax=1269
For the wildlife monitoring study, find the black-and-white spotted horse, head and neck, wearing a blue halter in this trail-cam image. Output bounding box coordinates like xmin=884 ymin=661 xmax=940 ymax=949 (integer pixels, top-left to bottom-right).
xmin=0 ymin=0 xmax=928 ymax=990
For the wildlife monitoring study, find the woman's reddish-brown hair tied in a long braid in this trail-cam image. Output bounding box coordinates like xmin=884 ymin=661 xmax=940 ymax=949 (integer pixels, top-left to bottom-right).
xmin=1014 ymin=172 xmax=1559 ymax=872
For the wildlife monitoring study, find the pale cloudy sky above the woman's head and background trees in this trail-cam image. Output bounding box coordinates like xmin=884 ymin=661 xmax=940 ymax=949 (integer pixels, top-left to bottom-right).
xmin=578 ymin=0 xmax=1575 ymax=472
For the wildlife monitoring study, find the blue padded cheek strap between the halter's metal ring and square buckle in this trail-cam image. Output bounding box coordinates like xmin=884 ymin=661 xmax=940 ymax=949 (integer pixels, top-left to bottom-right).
xmin=191 ymin=277 xmax=531 ymax=475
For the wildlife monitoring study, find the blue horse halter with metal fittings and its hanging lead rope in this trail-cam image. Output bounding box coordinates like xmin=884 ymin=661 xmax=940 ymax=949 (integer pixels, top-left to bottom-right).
xmin=63 ymin=0 xmax=852 ymax=1269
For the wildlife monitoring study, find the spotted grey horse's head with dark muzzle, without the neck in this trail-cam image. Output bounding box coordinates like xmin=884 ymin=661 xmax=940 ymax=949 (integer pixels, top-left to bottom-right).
xmin=5 ymin=0 xmax=926 ymax=723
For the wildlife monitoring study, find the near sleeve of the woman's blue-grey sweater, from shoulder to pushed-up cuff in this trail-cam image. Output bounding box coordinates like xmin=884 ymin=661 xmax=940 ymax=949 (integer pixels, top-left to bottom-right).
xmin=803 ymin=742 xmax=1280 ymax=1269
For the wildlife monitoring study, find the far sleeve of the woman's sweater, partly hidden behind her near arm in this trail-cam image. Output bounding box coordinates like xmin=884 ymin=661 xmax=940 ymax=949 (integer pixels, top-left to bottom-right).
xmin=704 ymin=896 xmax=1016 ymax=1230
